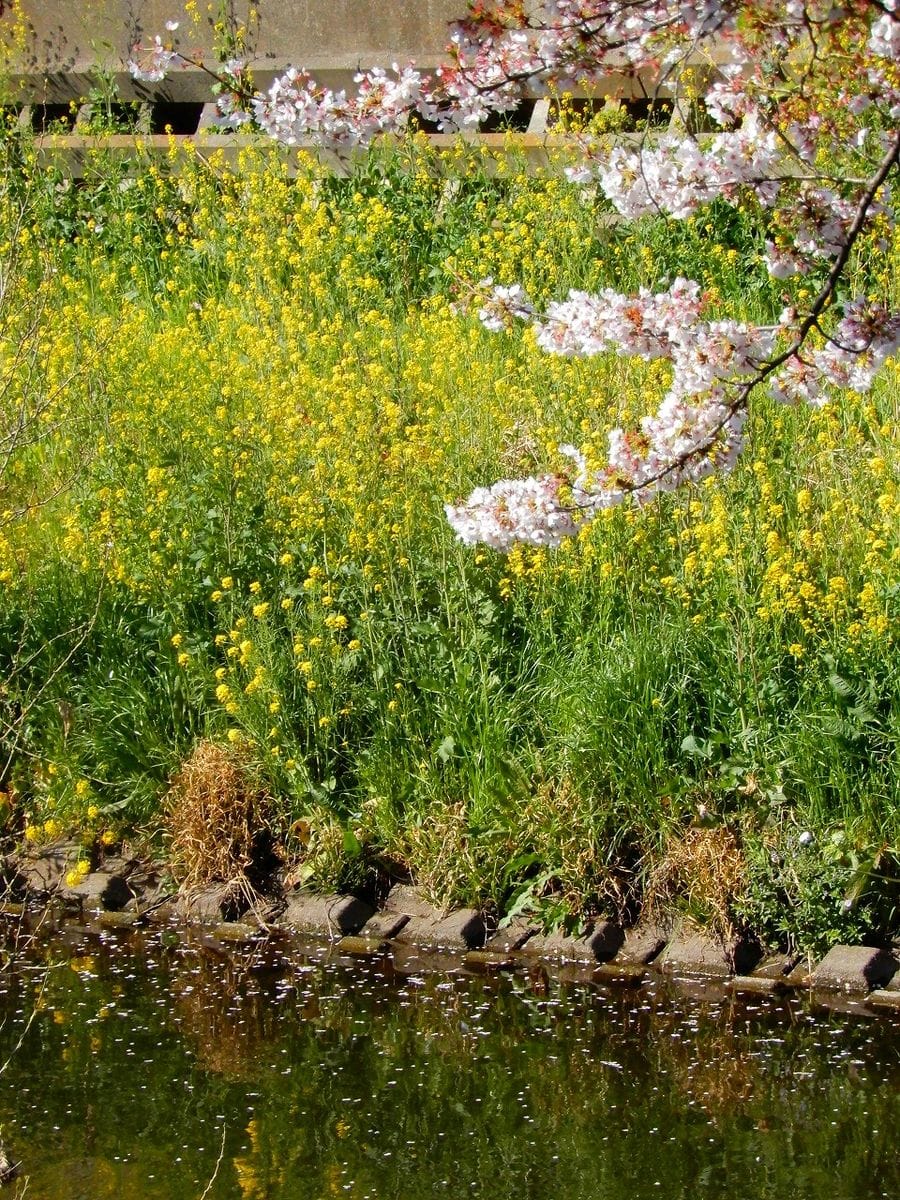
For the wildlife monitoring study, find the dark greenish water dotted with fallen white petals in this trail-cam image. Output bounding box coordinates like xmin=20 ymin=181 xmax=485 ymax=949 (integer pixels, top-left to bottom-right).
xmin=0 ymin=912 xmax=900 ymax=1200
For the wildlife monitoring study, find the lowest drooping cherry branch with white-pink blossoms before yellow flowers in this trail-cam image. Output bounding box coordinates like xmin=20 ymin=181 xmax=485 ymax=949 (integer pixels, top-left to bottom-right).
xmin=446 ymin=120 xmax=900 ymax=550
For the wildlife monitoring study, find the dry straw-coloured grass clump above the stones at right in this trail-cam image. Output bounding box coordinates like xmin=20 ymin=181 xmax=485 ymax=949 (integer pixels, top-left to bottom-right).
xmin=644 ymin=826 xmax=748 ymax=944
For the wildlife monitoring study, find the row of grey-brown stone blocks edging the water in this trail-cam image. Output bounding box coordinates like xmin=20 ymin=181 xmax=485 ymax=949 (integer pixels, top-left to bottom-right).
xmin=0 ymin=844 xmax=900 ymax=1014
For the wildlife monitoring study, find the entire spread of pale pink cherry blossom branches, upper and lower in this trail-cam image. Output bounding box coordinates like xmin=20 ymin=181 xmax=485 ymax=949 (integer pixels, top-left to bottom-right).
xmin=132 ymin=0 xmax=900 ymax=550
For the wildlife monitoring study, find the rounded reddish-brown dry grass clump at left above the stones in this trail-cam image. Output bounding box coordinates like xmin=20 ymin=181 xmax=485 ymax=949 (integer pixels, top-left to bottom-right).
xmin=164 ymin=740 xmax=271 ymax=890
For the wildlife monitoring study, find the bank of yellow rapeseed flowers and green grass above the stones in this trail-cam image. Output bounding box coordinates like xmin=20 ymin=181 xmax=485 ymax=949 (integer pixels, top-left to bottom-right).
xmin=0 ymin=133 xmax=900 ymax=948
